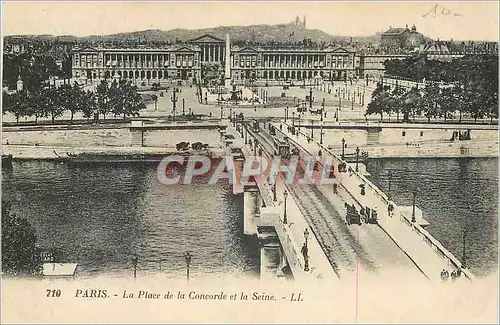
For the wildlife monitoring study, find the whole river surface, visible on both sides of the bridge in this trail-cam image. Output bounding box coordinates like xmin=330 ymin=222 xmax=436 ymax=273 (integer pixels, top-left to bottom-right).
xmin=2 ymin=158 xmax=498 ymax=277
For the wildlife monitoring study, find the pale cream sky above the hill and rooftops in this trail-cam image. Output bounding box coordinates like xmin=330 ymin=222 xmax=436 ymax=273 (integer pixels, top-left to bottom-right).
xmin=2 ymin=0 xmax=499 ymax=41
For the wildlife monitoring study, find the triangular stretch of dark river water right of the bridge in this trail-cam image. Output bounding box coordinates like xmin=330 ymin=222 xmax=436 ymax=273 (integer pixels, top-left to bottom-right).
xmin=367 ymin=158 xmax=498 ymax=276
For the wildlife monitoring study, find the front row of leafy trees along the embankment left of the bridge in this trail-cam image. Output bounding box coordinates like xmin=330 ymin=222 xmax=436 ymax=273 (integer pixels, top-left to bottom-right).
xmin=3 ymin=80 xmax=146 ymax=123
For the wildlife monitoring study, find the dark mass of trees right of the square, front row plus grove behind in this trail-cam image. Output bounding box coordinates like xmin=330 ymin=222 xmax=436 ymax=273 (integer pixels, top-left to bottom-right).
xmin=367 ymin=55 xmax=498 ymax=122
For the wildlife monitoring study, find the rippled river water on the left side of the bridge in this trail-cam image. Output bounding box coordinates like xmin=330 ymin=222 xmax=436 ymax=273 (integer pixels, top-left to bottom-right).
xmin=2 ymin=161 xmax=260 ymax=277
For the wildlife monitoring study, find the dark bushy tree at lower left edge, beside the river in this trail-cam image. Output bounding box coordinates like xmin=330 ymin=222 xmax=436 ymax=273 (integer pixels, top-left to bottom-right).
xmin=2 ymin=200 xmax=43 ymax=276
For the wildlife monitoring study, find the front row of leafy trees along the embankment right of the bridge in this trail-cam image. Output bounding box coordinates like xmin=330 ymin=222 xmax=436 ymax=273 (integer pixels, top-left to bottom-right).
xmin=366 ymin=82 xmax=498 ymax=123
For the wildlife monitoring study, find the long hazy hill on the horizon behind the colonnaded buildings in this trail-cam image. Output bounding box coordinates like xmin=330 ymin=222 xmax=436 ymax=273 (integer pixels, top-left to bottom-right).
xmin=6 ymin=22 xmax=380 ymax=43
